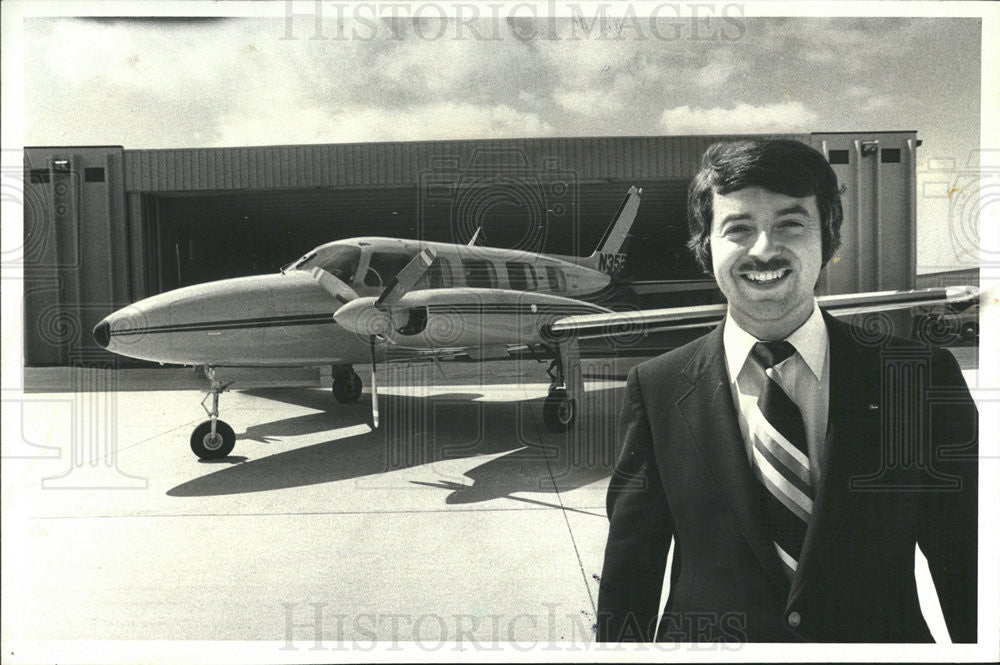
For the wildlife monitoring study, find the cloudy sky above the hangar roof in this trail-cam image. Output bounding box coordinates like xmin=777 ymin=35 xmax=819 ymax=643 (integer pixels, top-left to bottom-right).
xmin=9 ymin=3 xmax=981 ymax=271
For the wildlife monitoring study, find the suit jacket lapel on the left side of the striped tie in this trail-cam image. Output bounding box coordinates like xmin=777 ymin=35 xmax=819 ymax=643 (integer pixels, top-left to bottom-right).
xmin=676 ymin=325 xmax=786 ymax=584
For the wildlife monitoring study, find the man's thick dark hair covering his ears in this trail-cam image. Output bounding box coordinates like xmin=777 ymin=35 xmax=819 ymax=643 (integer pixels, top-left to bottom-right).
xmin=688 ymin=140 xmax=844 ymax=272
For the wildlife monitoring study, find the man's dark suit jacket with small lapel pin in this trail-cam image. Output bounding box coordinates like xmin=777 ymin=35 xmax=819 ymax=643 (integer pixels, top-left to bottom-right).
xmin=597 ymin=314 xmax=978 ymax=642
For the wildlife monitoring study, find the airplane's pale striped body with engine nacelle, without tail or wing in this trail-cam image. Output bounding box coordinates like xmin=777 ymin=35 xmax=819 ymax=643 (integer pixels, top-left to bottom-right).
xmin=94 ymin=237 xmax=611 ymax=366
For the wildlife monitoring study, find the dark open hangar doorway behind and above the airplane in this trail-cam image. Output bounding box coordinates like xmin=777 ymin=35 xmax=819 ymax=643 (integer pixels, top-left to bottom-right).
xmin=146 ymin=179 xmax=703 ymax=295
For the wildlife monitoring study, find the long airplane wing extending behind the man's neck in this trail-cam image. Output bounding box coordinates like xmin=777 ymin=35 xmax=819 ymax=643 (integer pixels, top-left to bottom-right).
xmin=548 ymin=286 xmax=979 ymax=339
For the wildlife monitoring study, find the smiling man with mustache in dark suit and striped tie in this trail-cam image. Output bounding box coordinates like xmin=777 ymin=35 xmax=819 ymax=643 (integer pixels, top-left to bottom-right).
xmin=597 ymin=141 xmax=977 ymax=642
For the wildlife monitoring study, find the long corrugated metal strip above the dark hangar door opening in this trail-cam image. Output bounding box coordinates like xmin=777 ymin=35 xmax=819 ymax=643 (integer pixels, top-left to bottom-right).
xmin=125 ymin=134 xmax=811 ymax=192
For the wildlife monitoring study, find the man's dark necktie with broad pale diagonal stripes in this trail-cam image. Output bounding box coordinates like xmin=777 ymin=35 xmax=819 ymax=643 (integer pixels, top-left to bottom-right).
xmin=747 ymin=342 xmax=813 ymax=581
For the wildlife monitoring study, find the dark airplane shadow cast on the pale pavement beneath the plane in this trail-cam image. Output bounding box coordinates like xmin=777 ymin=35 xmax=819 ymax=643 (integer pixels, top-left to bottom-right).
xmin=167 ymin=389 xmax=620 ymax=504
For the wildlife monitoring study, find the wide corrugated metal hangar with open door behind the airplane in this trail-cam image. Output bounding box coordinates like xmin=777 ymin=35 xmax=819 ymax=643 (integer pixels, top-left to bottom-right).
xmin=24 ymin=131 xmax=919 ymax=366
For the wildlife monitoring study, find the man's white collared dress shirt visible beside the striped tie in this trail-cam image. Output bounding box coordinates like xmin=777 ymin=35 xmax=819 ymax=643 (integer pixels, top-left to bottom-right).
xmin=722 ymin=301 xmax=830 ymax=488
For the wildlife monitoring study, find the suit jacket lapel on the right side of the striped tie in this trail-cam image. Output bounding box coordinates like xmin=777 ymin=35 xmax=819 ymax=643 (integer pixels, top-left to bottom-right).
xmin=788 ymin=312 xmax=869 ymax=605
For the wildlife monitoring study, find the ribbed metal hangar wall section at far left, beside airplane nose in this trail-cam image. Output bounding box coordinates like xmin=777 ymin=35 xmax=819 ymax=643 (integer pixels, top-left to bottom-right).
xmin=22 ymin=146 xmax=129 ymax=365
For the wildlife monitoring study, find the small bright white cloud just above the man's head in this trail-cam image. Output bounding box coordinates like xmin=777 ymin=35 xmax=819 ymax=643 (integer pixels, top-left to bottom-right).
xmin=660 ymin=102 xmax=819 ymax=134
